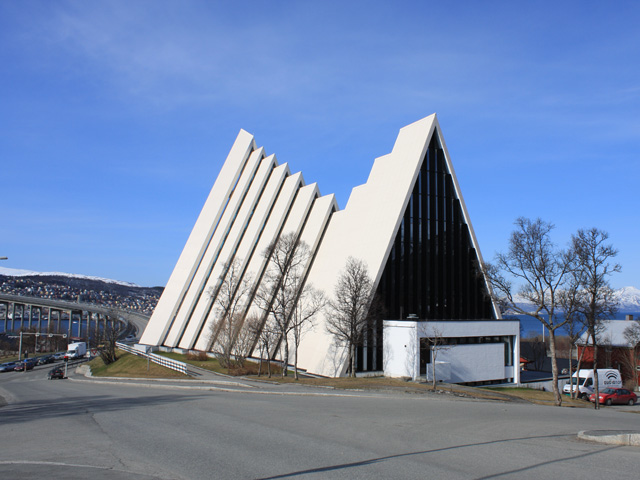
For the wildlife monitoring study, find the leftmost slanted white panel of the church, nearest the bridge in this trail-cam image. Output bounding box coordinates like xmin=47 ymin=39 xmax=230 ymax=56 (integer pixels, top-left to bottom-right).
xmin=140 ymin=130 xmax=255 ymax=345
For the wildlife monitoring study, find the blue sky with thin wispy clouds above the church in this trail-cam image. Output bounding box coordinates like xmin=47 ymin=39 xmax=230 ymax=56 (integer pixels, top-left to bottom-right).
xmin=0 ymin=0 xmax=640 ymax=287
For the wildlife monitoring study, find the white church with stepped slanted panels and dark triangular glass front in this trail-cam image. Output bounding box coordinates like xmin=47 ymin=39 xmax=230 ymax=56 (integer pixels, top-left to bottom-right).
xmin=140 ymin=114 xmax=519 ymax=383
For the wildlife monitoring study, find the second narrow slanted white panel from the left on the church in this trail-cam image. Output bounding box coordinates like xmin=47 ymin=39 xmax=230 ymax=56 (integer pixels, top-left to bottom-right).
xmin=164 ymin=148 xmax=264 ymax=347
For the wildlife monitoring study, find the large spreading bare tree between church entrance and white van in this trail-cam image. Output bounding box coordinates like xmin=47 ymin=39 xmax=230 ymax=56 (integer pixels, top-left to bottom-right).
xmin=484 ymin=217 xmax=574 ymax=406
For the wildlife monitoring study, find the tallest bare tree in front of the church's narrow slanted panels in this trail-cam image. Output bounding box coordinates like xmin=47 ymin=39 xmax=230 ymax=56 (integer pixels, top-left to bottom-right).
xmin=256 ymin=232 xmax=311 ymax=377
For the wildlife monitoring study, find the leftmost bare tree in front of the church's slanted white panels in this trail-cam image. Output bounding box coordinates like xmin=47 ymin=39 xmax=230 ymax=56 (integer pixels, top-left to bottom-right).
xmin=208 ymin=259 xmax=251 ymax=368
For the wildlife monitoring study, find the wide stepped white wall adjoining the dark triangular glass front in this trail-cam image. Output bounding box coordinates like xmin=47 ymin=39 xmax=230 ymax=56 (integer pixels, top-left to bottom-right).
xmin=298 ymin=115 xmax=435 ymax=376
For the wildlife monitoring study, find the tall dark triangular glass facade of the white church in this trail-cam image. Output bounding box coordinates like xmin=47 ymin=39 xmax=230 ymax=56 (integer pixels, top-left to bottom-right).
xmin=357 ymin=132 xmax=495 ymax=376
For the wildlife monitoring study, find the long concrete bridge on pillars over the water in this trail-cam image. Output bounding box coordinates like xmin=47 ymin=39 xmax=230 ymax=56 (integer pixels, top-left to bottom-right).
xmin=0 ymin=293 xmax=149 ymax=338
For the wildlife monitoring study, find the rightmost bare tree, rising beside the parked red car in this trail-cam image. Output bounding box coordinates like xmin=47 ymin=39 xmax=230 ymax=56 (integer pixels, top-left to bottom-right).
xmin=571 ymin=228 xmax=621 ymax=409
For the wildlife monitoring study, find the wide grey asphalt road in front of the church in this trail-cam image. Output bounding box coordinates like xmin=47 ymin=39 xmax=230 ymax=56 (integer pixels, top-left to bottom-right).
xmin=0 ymin=369 xmax=640 ymax=480
